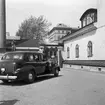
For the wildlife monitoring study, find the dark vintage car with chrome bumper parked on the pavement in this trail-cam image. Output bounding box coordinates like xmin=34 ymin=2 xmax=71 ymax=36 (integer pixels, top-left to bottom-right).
xmin=0 ymin=51 xmax=60 ymax=83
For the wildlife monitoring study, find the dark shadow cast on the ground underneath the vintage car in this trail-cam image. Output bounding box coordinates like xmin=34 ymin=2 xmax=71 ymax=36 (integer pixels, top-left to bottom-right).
xmin=0 ymin=75 xmax=62 ymax=86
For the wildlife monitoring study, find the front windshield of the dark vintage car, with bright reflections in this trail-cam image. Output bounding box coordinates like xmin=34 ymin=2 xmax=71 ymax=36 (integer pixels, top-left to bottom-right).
xmin=2 ymin=53 xmax=23 ymax=60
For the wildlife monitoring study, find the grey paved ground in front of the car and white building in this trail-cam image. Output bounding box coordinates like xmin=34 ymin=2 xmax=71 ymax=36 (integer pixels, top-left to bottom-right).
xmin=0 ymin=69 xmax=105 ymax=105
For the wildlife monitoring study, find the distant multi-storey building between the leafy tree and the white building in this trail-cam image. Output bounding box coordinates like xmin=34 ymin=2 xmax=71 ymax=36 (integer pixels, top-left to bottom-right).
xmin=48 ymin=23 xmax=78 ymax=43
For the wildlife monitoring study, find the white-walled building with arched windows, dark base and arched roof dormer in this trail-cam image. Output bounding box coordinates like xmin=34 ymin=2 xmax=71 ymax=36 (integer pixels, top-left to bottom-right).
xmin=60 ymin=0 xmax=105 ymax=67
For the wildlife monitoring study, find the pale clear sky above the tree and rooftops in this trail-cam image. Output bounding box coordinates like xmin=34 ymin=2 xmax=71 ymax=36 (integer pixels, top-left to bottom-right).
xmin=6 ymin=0 xmax=97 ymax=36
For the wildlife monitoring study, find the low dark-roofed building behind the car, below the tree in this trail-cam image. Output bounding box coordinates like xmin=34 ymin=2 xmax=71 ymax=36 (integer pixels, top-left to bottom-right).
xmin=6 ymin=32 xmax=39 ymax=51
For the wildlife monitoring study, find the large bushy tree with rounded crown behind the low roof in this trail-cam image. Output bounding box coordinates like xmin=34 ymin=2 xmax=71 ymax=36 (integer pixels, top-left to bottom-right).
xmin=16 ymin=16 xmax=51 ymax=41
